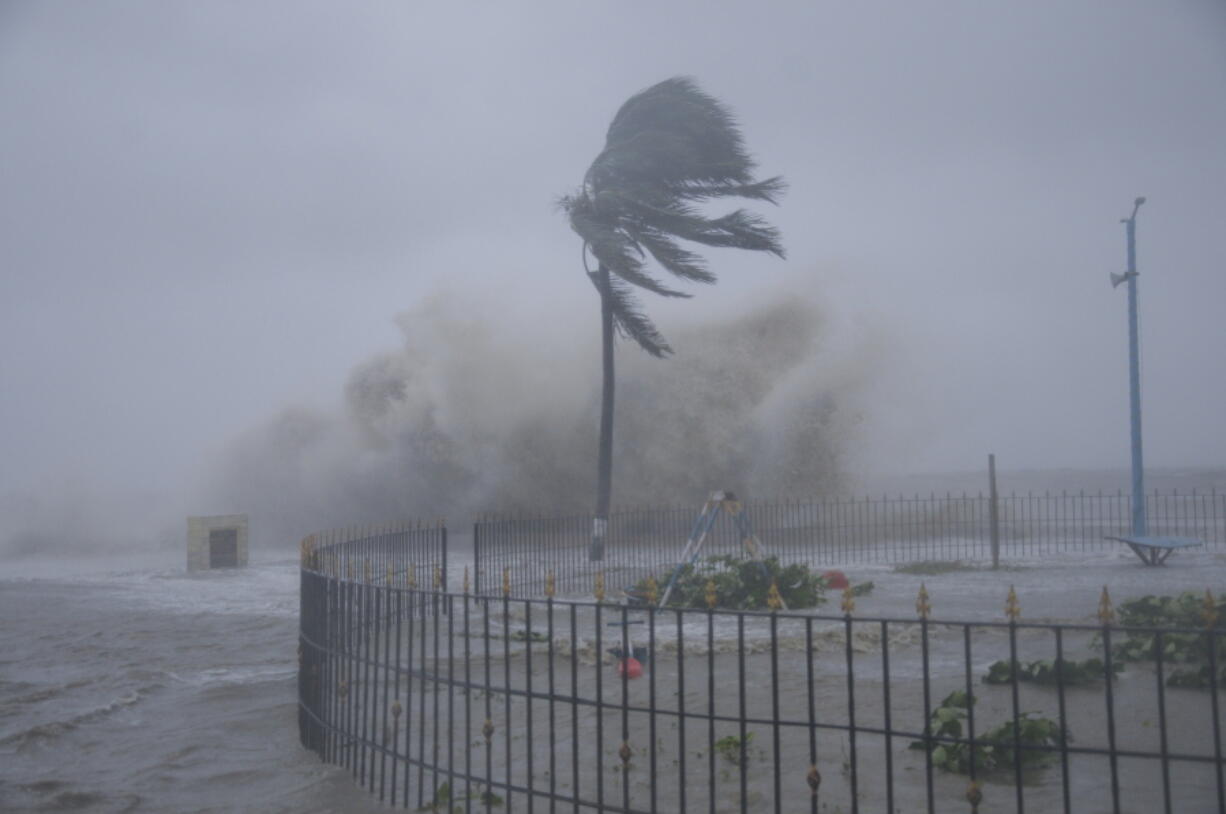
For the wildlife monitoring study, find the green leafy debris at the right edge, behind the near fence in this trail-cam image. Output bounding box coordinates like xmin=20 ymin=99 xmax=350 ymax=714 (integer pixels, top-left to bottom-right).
xmin=1095 ymin=591 xmax=1226 ymax=688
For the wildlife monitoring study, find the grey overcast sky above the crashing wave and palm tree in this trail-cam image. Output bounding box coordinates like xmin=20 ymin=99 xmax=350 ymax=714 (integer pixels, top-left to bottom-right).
xmin=0 ymin=0 xmax=1226 ymax=502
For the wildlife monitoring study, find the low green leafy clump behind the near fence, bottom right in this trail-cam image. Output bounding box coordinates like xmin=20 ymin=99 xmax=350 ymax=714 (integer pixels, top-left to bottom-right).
xmin=911 ymin=690 xmax=1073 ymax=775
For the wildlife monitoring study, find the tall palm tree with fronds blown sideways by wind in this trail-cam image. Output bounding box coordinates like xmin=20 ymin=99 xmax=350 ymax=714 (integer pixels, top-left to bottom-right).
xmin=560 ymin=76 xmax=783 ymax=560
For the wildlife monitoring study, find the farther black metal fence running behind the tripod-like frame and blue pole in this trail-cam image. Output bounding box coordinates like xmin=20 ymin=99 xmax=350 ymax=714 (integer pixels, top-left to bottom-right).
xmin=473 ymin=492 xmax=1226 ymax=595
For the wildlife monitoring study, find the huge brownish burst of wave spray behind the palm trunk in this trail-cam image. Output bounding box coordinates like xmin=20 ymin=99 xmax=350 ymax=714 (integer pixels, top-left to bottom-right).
xmin=196 ymin=283 xmax=879 ymax=542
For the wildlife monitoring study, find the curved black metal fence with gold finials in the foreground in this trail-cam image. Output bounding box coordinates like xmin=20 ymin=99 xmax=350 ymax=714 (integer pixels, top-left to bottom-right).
xmin=299 ymin=531 xmax=1226 ymax=814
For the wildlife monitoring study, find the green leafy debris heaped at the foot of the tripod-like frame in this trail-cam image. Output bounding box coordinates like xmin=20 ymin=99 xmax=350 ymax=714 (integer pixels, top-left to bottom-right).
xmin=633 ymin=554 xmax=826 ymax=611
